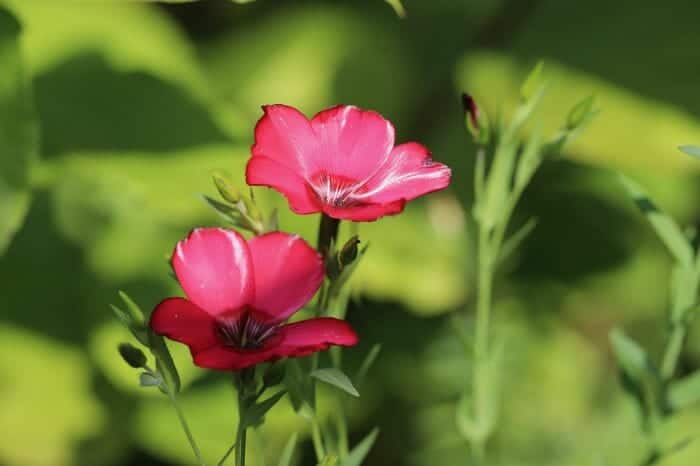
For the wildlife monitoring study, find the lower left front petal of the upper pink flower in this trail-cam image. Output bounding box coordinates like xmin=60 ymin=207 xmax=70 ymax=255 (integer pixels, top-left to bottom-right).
xmin=246 ymin=156 xmax=321 ymax=214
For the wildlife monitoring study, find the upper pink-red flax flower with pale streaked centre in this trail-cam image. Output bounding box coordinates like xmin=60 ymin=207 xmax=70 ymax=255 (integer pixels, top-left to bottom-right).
xmin=246 ymin=105 xmax=450 ymax=221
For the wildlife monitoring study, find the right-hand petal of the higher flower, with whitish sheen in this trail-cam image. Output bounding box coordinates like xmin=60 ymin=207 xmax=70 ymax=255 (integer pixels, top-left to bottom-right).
xmin=356 ymin=142 xmax=451 ymax=203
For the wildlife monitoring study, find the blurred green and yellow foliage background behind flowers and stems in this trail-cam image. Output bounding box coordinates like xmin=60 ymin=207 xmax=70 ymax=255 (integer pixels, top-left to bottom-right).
xmin=0 ymin=0 xmax=700 ymax=466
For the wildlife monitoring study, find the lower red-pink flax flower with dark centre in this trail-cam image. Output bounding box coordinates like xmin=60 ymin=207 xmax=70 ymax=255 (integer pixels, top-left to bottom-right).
xmin=151 ymin=228 xmax=357 ymax=370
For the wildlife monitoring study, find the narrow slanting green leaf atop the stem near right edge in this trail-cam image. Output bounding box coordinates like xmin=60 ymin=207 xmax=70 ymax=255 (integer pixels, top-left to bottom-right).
xmin=620 ymin=175 xmax=693 ymax=265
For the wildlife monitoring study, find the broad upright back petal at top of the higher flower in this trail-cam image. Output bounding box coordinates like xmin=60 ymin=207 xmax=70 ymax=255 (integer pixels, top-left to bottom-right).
xmin=310 ymin=105 xmax=394 ymax=183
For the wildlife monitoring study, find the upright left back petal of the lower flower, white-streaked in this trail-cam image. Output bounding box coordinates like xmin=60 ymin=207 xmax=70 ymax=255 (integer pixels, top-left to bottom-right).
xmin=172 ymin=228 xmax=255 ymax=315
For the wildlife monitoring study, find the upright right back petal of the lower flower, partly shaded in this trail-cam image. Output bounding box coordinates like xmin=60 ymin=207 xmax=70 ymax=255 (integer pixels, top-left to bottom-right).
xmin=248 ymin=233 xmax=323 ymax=322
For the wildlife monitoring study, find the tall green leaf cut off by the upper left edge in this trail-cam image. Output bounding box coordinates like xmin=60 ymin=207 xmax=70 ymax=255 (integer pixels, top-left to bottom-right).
xmin=0 ymin=8 xmax=39 ymax=254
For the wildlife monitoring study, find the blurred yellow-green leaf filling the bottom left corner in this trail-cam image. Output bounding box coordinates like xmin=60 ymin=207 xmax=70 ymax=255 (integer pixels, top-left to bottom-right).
xmin=0 ymin=323 xmax=105 ymax=466
